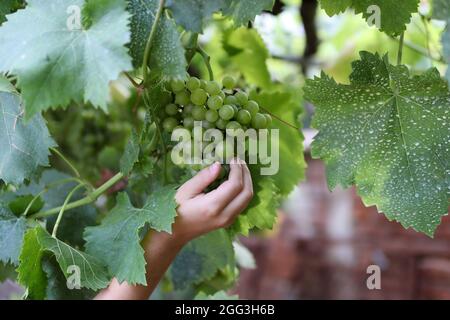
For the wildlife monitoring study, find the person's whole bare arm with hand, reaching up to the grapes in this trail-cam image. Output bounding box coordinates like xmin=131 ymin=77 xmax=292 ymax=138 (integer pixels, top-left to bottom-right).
xmin=96 ymin=160 xmax=253 ymax=300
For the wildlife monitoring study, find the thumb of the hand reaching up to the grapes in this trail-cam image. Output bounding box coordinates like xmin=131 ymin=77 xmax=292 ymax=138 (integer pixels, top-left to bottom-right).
xmin=175 ymin=162 xmax=221 ymax=203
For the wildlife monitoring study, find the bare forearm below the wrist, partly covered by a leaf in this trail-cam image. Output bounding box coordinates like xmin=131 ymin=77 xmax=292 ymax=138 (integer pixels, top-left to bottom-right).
xmin=95 ymin=232 xmax=183 ymax=300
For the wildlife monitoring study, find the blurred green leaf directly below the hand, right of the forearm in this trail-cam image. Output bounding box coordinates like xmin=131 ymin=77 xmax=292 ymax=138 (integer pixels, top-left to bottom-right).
xmin=169 ymin=229 xmax=235 ymax=290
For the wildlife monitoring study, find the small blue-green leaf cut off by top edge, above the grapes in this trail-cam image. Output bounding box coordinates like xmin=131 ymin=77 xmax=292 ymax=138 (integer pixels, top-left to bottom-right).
xmin=166 ymin=0 xmax=231 ymax=33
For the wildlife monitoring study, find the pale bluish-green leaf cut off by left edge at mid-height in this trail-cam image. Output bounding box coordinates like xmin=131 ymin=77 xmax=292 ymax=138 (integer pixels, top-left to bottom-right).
xmin=0 ymin=90 xmax=55 ymax=185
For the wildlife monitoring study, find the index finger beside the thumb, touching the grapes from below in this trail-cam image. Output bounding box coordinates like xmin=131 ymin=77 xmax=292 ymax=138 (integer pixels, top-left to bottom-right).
xmin=205 ymin=159 xmax=244 ymax=211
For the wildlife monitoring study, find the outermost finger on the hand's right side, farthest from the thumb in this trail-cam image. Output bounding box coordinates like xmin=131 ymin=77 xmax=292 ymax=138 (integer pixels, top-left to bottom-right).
xmin=222 ymin=160 xmax=253 ymax=225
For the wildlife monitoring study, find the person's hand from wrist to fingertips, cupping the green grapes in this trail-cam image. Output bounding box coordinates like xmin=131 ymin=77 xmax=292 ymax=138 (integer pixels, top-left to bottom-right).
xmin=172 ymin=159 xmax=253 ymax=244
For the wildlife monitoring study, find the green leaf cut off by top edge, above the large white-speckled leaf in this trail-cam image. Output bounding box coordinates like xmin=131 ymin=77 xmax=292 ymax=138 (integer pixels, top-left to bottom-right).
xmin=320 ymin=0 xmax=420 ymax=36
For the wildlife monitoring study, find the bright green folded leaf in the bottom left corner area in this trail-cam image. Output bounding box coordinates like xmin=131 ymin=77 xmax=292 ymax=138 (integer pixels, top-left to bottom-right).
xmin=17 ymin=227 xmax=110 ymax=299
